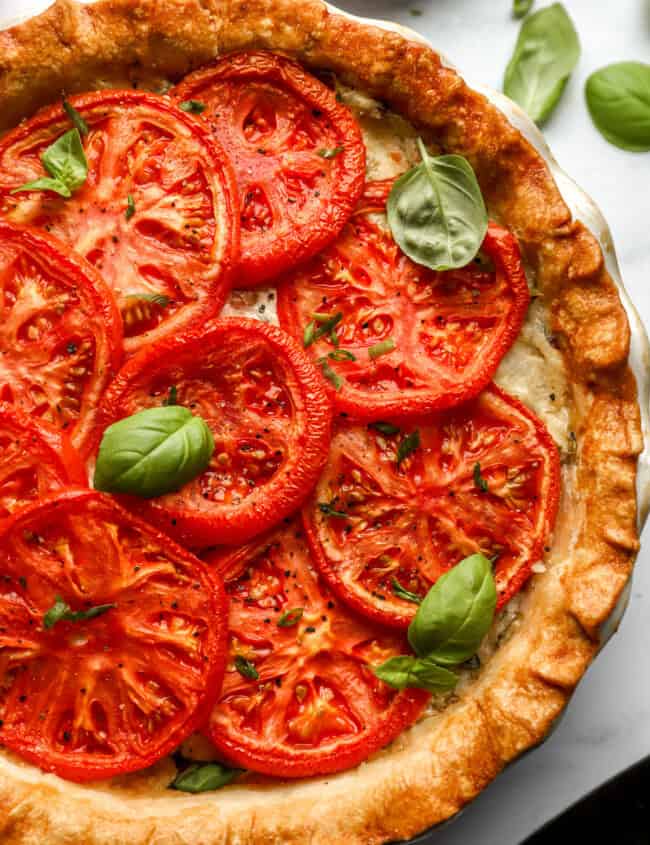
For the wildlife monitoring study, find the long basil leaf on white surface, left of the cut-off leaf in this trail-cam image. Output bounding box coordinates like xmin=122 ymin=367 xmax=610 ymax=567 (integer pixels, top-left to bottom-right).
xmin=503 ymin=3 xmax=580 ymax=124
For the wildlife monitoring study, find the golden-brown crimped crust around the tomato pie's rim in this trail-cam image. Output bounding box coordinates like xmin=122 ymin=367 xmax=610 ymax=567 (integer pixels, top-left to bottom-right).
xmin=0 ymin=0 xmax=642 ymax=845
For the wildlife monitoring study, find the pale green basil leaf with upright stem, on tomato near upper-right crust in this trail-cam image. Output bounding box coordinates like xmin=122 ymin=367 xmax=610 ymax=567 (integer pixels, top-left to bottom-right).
xmin=386 ymin=138 xmax=488 ymax=270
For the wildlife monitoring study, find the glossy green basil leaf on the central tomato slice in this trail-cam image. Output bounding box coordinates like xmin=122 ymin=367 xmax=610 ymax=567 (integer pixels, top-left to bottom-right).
xmin=94 ymin=405 xmax=214 ymax=499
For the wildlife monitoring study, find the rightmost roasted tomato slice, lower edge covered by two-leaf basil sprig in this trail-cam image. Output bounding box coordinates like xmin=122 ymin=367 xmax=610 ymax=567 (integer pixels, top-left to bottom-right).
xmin=305 ymin=386 xmax=560 ymax=627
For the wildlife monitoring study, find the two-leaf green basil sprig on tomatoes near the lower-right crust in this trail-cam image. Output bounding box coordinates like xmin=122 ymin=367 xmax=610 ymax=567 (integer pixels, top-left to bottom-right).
xmin=373 ymin=554 xmax=497 ymax=692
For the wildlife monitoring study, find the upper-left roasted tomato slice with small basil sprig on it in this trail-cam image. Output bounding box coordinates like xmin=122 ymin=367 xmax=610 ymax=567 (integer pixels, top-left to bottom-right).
xmin=0 ymin=91 xmax=239 ymax=353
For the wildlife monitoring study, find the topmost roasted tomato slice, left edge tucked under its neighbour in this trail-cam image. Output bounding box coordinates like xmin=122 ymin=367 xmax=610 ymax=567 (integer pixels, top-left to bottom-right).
xmin=174 ymin=52 xmax=365 ymax=287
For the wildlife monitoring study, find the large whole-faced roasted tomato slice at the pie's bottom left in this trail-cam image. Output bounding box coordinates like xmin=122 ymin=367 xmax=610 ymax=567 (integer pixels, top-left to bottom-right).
xmin=0 ymin=491 xmax=227 ymax=781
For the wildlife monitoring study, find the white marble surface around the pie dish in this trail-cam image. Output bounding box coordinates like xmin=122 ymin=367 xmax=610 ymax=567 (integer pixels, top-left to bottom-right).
xmin=0 ymin=0 xmax=650 ymax=845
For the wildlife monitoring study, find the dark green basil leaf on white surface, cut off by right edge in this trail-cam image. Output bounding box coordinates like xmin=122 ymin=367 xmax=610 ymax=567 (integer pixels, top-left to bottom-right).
xmin=585 ymin=62 xmax=650 ymax=153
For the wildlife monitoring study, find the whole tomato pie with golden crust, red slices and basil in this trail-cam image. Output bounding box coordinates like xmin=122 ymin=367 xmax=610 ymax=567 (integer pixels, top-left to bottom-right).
xmin=0 ymin=0 xmax=643 ymax=845
